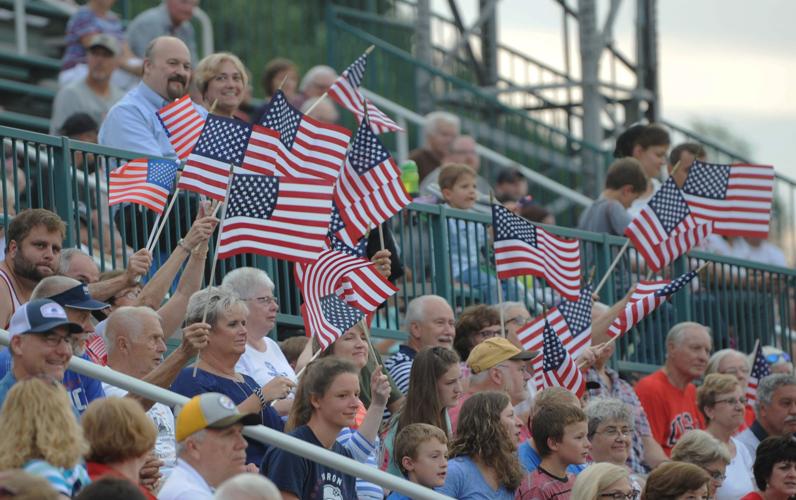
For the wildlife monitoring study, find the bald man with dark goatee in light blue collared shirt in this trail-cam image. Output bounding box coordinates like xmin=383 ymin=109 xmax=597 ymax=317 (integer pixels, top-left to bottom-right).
xmin=99 ymin=36 xmax=207 ymax=159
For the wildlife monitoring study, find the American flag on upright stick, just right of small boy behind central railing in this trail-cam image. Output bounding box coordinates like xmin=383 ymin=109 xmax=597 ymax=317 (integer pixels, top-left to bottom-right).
xmin=492 ymin=204 xmax=580 ymax=301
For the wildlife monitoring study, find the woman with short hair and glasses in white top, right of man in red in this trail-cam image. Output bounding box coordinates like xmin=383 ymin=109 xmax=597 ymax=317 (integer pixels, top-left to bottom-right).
xmin=697 ymin=373 xmax=754 ymax=500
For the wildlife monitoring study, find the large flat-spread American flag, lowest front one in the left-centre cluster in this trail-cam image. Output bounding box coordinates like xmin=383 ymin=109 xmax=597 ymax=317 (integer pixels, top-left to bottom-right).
xmin=218 ymin=174 xmax=334 ymax=262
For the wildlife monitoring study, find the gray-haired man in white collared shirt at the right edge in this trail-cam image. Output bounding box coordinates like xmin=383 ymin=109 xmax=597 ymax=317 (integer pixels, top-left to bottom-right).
xmin=736 ymin=373 xmax=796 ymax=456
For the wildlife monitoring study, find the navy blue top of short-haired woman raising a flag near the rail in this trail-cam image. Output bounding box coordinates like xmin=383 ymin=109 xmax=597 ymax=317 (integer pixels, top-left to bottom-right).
xmin=171 ymin=367 xmax=285 ymax=466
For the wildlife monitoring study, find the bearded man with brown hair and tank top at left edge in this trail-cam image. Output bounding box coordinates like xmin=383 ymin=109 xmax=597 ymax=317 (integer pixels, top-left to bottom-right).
xmin=0 ymin=208 xmax=66 ymax=328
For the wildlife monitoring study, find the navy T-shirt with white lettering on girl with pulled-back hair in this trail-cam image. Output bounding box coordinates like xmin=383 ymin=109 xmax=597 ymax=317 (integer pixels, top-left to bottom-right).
xmin=260 ymin=425 xmax=357 ymax=500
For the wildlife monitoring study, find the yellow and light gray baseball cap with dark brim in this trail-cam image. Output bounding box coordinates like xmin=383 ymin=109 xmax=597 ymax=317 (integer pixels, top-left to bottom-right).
xmin=175 ymin=392 xmax=262 ymax=441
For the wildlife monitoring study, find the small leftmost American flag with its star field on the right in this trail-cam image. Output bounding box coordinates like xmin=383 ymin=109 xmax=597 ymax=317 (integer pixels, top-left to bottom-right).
xmin=108 ymin=158 xmax=180 ymax=214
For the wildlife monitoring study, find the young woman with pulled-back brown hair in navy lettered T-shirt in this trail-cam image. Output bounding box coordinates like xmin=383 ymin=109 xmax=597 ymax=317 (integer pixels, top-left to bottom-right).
xmin=261 ymin=358 xmax=359 ymax=500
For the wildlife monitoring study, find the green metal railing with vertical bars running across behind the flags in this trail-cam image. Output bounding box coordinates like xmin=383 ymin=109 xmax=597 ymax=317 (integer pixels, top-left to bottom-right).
xmin=0 ymin=127 xmax=796 ymax=371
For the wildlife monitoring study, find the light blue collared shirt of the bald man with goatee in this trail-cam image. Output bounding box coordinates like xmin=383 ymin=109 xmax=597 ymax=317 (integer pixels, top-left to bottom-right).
xmin=99 ymin=82 xmax=207 ymax=160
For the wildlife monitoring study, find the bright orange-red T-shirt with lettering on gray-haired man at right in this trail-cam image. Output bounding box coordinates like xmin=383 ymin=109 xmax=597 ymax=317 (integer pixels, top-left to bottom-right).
xmin=636 ymin=370 xmax=704 ymax=456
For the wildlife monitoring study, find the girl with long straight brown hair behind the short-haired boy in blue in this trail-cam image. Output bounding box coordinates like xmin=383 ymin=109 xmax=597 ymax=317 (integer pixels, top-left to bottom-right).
xmin=382 ymin=346 xmax=462 ymax=476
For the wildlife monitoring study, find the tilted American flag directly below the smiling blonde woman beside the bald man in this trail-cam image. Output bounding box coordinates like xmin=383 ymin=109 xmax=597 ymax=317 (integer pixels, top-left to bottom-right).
xmin=177 ymin=115 xmax=252 ymax=201
